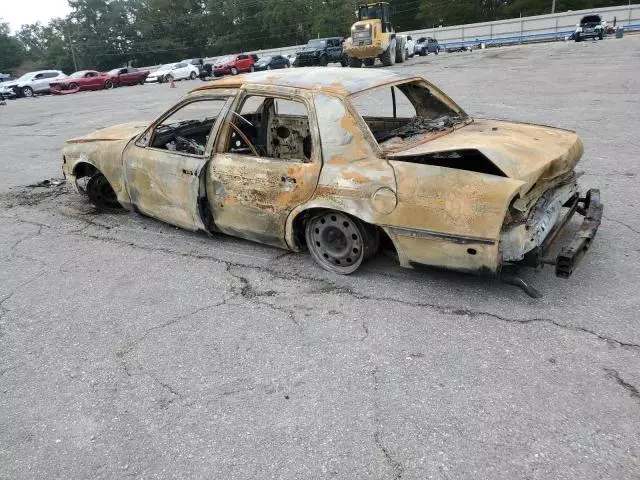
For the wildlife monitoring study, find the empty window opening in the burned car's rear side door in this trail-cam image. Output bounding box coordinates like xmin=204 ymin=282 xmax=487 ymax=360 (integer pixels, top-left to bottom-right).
xmin=225 ymin=95 xmax=313 ymax=162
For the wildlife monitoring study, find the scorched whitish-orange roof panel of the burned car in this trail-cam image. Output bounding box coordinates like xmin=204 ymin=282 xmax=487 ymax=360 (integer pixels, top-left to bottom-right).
xmin=191 ymin=67 xmax=423 ymax=95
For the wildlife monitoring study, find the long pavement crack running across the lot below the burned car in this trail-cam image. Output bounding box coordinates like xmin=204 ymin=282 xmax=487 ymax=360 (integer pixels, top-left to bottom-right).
xmin=4 ymin=217 xmax=640 ymax=349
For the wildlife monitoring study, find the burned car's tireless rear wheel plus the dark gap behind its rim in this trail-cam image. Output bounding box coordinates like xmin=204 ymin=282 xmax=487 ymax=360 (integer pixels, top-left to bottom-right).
xmin=305 ymin=210 xmax=376 ymax=275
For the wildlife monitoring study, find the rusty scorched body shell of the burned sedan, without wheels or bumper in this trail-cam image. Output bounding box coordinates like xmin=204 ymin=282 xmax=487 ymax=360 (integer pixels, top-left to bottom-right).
xmin=63 ymin=68 xmax=596 ymax=273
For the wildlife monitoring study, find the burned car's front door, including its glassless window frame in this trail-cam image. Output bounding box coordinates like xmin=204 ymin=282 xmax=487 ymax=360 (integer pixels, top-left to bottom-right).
xmin=123 ymin=94 xmax=234 ymax=230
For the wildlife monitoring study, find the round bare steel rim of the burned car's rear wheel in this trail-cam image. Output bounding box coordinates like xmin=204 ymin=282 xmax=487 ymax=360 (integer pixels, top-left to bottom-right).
xmin=309 ymin=212 xmax=365 ymax=273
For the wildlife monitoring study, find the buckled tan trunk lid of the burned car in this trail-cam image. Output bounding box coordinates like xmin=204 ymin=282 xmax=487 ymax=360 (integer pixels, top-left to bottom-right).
xmin=389 ymin=119 xmax=584 ymax=192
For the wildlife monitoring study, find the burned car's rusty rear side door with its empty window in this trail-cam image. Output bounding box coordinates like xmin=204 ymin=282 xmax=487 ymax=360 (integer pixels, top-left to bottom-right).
xmin=207 ymin=89 xmax=322 ymax=247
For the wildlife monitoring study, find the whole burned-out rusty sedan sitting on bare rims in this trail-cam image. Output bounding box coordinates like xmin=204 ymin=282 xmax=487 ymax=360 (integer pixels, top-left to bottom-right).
xmin=63 ymin=68 xmax=602 ymax=292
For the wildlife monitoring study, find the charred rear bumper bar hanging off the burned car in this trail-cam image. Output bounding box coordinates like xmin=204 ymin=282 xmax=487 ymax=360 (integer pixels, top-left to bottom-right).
xmin=520 ymin=189 xmax=604 ymax=278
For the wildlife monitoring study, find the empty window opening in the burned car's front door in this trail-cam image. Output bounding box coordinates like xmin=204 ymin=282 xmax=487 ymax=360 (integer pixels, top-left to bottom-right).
xmin=148 ymin=98 xmax=227 ymax=156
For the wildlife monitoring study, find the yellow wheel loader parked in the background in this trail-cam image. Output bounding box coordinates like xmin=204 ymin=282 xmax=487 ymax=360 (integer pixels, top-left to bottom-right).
xmin=344 ymin=2 xmax=407 ymax=68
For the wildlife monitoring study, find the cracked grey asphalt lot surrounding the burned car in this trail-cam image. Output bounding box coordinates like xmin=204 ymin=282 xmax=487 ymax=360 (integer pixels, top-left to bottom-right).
xmin=0 ymin=36 xmax=640 ymax=480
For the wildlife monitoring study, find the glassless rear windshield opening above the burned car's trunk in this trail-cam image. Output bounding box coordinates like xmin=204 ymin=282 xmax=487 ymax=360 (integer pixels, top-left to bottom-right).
xmin=352 ymin=81 xmax=469 ymax=151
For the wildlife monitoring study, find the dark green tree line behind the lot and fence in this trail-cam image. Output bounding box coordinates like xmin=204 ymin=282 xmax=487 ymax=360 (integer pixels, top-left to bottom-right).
xmin=0 ymin=0 xmax=632 ymax=73
